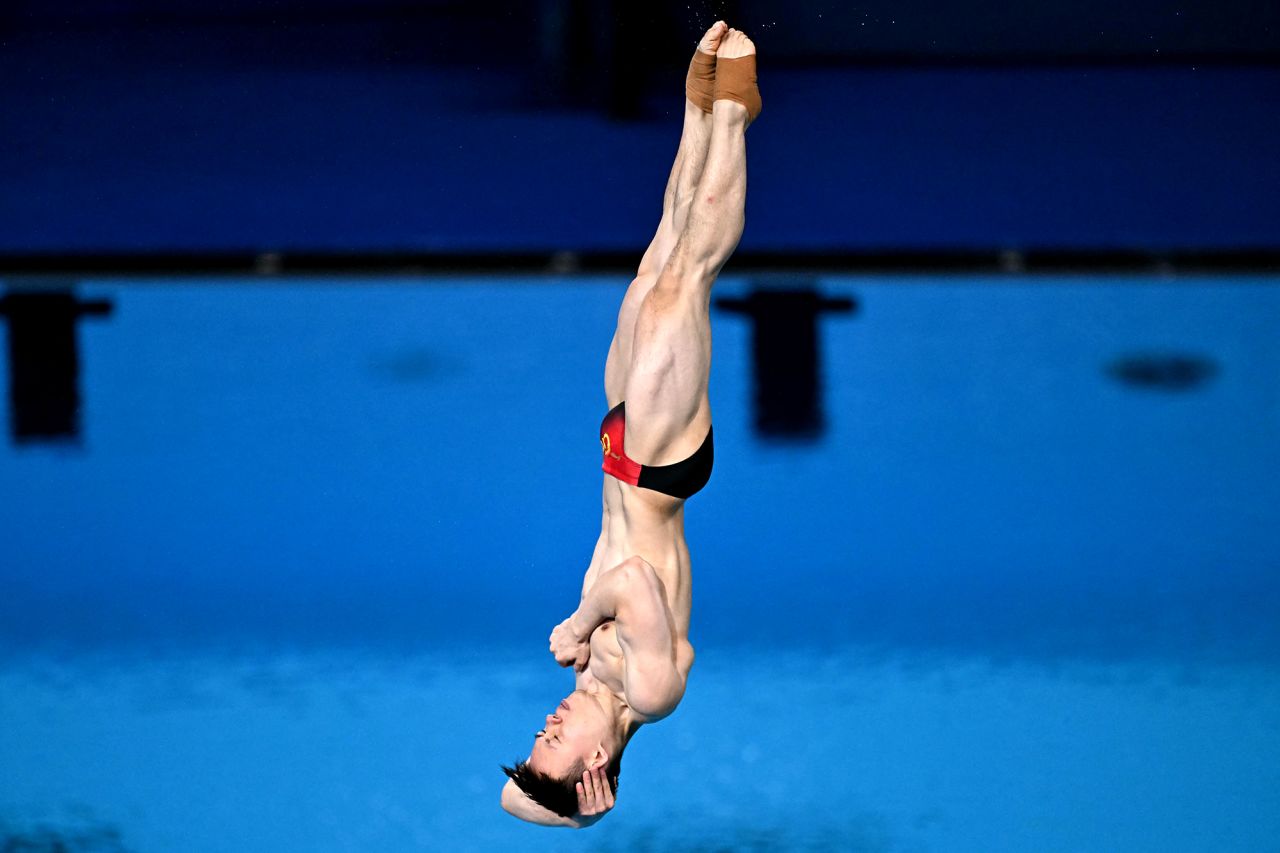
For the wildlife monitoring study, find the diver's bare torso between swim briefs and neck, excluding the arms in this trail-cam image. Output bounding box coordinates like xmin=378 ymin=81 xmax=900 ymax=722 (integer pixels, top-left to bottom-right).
xmin=579 ymin=475 xmax=694 ymax=697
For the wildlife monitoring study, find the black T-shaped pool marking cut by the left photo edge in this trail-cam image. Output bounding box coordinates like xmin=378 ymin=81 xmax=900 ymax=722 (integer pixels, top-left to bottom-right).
xmin=0 ymin=287 xmax=111 ymax=444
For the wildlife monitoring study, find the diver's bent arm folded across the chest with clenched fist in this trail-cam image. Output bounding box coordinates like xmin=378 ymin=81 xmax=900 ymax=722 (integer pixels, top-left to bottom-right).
xmin=564 ymin=557 xmax=685 ymax=721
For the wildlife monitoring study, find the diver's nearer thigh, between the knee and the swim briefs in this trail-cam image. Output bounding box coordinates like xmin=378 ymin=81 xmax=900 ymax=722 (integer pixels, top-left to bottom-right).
xmin=623 ymin=280 xmax=712 ymax=465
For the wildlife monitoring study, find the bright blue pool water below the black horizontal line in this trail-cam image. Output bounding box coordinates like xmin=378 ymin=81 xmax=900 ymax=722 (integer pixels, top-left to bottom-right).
xmin=0 ymin=275 xmax=1280 ymax=850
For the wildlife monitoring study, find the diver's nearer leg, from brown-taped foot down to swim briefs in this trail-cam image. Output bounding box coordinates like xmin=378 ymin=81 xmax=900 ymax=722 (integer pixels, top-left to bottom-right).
xmin=625 ymin=29 xmax=759 ymax=465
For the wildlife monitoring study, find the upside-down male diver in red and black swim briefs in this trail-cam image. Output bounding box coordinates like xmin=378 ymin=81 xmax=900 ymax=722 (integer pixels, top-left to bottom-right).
xmin=502 ymin=20 xmax=760 ymax=827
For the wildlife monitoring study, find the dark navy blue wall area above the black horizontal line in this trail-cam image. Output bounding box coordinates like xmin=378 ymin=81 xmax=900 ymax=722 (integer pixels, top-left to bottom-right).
xmin=0 ymin=0 xmax=1280 ymax=254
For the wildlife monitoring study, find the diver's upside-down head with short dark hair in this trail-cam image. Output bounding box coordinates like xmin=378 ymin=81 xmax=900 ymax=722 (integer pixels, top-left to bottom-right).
xmin=503 ymin=690 xmax=626 ymax=817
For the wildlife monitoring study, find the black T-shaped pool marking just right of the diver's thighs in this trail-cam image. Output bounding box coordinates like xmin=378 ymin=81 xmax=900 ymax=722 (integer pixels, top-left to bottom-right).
xmin=716 ymin=283 xmax=856 ymax=442
